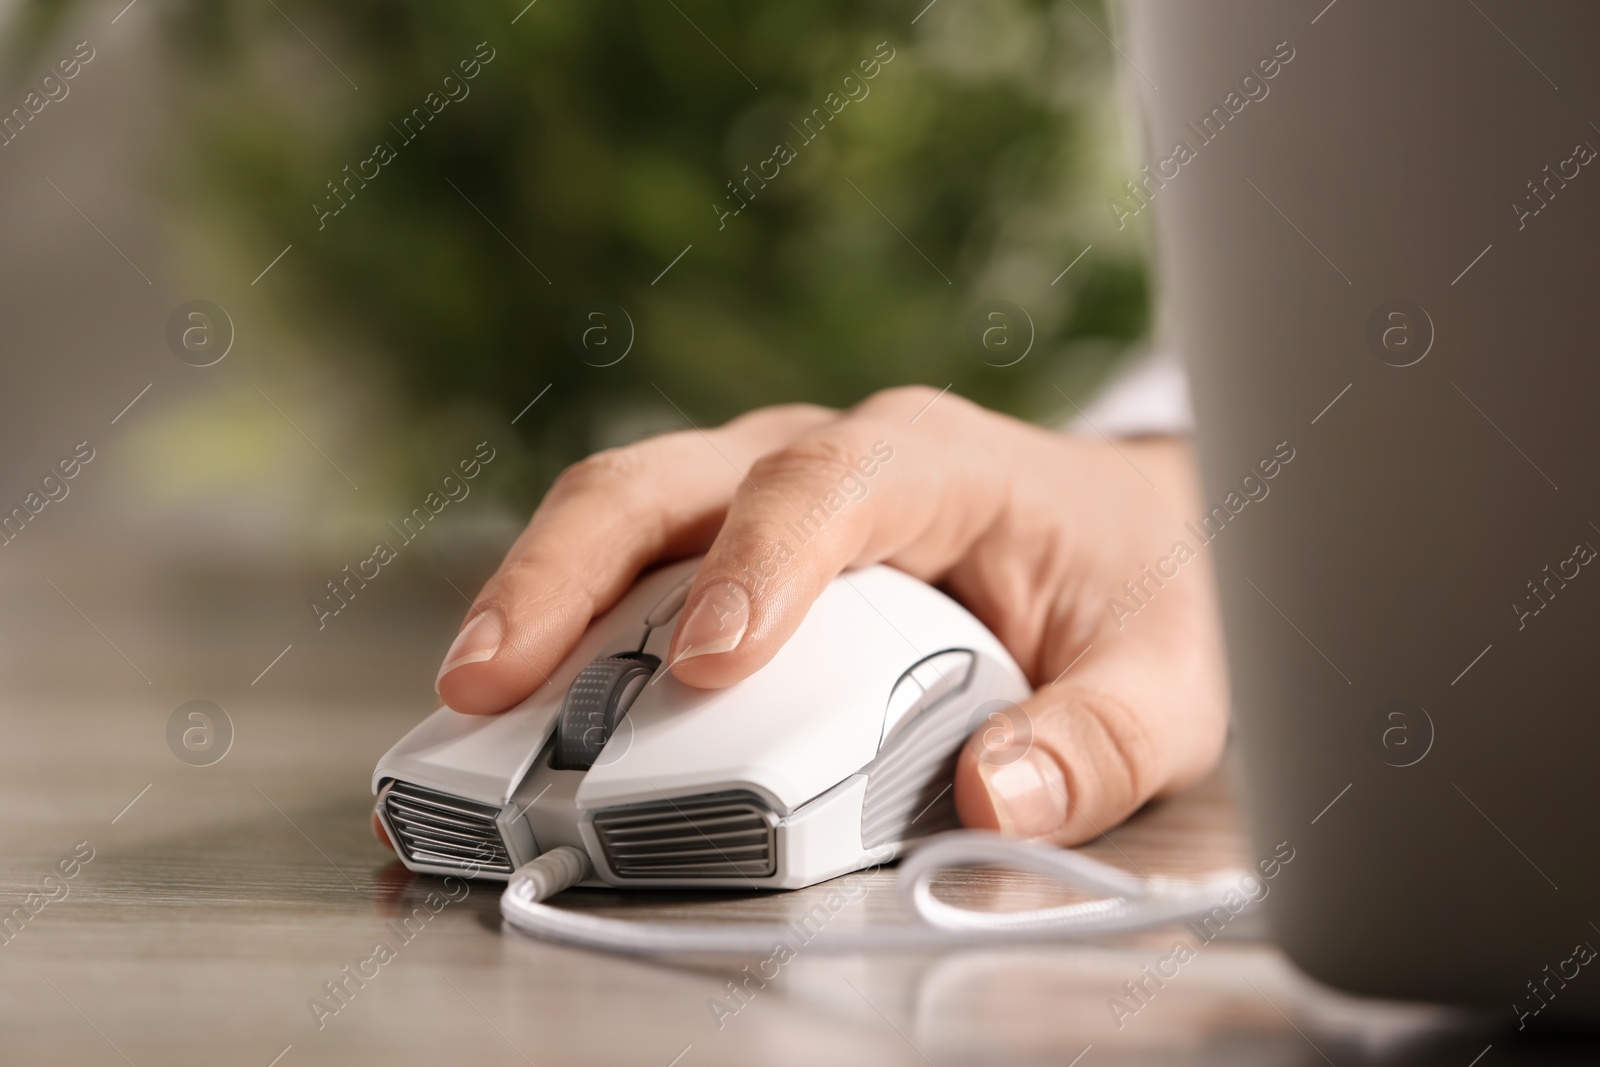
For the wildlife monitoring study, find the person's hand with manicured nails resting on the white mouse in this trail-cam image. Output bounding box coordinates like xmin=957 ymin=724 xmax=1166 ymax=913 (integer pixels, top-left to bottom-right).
xmin=422 ymin=387 xmax=1227 ymax=845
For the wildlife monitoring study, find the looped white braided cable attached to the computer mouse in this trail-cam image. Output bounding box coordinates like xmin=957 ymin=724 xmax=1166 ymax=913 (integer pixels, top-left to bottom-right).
xmin=501 ymin=830 xmax=1243 ymax=955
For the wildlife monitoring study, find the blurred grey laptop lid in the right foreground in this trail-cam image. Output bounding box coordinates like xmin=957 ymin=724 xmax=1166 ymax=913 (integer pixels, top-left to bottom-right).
xmin=1126 ymin=0 xmax=1600 ymax=1029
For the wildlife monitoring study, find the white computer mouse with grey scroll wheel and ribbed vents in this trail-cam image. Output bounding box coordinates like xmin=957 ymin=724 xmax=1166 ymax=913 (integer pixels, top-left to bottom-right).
xmin=373 ymin=558 xmax=1032 ymax=889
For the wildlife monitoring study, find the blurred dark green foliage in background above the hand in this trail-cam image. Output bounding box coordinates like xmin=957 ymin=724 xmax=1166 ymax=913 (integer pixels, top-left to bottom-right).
xmin=16 ymin=0 xmax=1149 ymax=502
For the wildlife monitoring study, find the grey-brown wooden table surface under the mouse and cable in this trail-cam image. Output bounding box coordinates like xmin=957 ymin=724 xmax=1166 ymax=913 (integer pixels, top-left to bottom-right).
xmin=0 ymin=556 xmax=1582 ymax=1067
